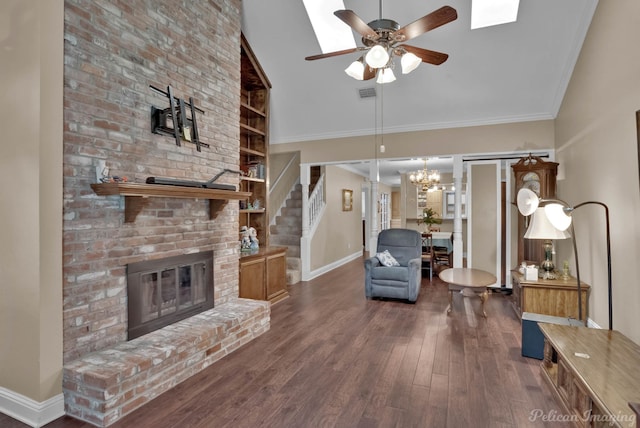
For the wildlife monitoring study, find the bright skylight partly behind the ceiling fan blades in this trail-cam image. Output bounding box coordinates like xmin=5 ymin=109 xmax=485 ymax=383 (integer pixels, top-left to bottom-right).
xmin=303 ymin=0 xmax=356 ymax=53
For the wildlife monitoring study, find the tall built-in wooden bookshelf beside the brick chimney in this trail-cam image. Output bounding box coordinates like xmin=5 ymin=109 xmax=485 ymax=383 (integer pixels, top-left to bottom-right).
xmin=239 ymin=36 xmax=271 ymax=247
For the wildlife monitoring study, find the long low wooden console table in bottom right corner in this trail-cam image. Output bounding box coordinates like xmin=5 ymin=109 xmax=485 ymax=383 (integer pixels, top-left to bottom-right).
xmin=539 ymin=323 xmax=640 ymax=428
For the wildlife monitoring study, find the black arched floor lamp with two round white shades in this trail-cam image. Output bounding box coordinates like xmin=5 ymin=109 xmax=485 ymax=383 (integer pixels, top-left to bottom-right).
xmin=517 ymin=189 xmax=613 ymax=330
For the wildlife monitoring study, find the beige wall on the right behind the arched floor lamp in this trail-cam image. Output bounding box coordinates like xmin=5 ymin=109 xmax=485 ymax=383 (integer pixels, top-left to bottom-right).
xmin=556 ymin=0 xmax=640 ymax=343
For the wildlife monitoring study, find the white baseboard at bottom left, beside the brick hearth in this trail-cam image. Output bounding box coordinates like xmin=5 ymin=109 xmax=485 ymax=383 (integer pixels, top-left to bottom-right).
xmin=0 ymin=387 xmax=64 ymax=428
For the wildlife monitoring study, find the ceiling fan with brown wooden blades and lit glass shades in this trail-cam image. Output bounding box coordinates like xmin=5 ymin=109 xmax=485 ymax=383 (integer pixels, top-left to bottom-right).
xmin=305 ymin=0 xmax=458 ymax=83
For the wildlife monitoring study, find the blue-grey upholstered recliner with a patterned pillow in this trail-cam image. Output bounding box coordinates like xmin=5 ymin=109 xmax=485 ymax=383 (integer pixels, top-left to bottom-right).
xmin=364 ymin=229 xmax=422 ymax=302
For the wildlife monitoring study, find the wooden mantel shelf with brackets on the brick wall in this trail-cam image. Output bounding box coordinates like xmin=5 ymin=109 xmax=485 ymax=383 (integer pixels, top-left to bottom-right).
xmin=91 ymin=183 xmax=251 ymax=223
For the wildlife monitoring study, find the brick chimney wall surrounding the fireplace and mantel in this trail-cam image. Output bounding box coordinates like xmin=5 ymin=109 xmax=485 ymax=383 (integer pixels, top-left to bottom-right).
xmin=63 ymin=0 xmax=241 ymax=362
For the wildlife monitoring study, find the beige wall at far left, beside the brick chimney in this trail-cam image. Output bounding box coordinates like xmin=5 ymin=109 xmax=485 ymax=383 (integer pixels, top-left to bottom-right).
xmin=0 ymin=0 xmax=64 ymax=402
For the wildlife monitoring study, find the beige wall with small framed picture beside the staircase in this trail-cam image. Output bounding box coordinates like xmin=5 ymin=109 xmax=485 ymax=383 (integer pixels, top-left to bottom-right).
xmin=310 ymin=165 xmax=365 ymax=271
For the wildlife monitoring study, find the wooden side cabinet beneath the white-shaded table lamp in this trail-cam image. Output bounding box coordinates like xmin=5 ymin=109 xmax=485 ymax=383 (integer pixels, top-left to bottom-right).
xmin=511 ymin=270 xmax=591 ymax=321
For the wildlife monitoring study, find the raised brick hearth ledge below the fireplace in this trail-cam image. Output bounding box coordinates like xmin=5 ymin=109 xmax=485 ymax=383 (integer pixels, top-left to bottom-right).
xmin=63 ymin=299 xmax=270 ymax=427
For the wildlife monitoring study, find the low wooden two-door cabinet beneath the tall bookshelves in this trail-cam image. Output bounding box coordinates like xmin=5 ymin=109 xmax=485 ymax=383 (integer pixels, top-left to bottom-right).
xmin=240 ymin=247 xmax=289 ymax=303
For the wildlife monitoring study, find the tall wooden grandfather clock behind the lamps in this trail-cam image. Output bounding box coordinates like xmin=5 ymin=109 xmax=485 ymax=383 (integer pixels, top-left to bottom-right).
xmin=511 ymin=154 xmax=558 ymax=265
